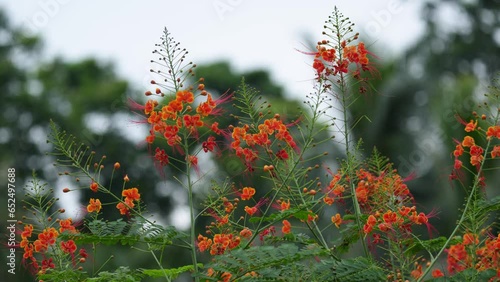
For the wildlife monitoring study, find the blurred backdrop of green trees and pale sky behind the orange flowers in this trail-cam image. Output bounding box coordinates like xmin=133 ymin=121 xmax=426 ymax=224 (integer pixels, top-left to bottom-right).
xmin=0 ymin=0 xmax=500 ymax=281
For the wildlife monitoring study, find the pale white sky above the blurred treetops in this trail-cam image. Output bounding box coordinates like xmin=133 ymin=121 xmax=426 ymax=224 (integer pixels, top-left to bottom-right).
xmin=0 ymin=0 xmax=422 ymax=97
